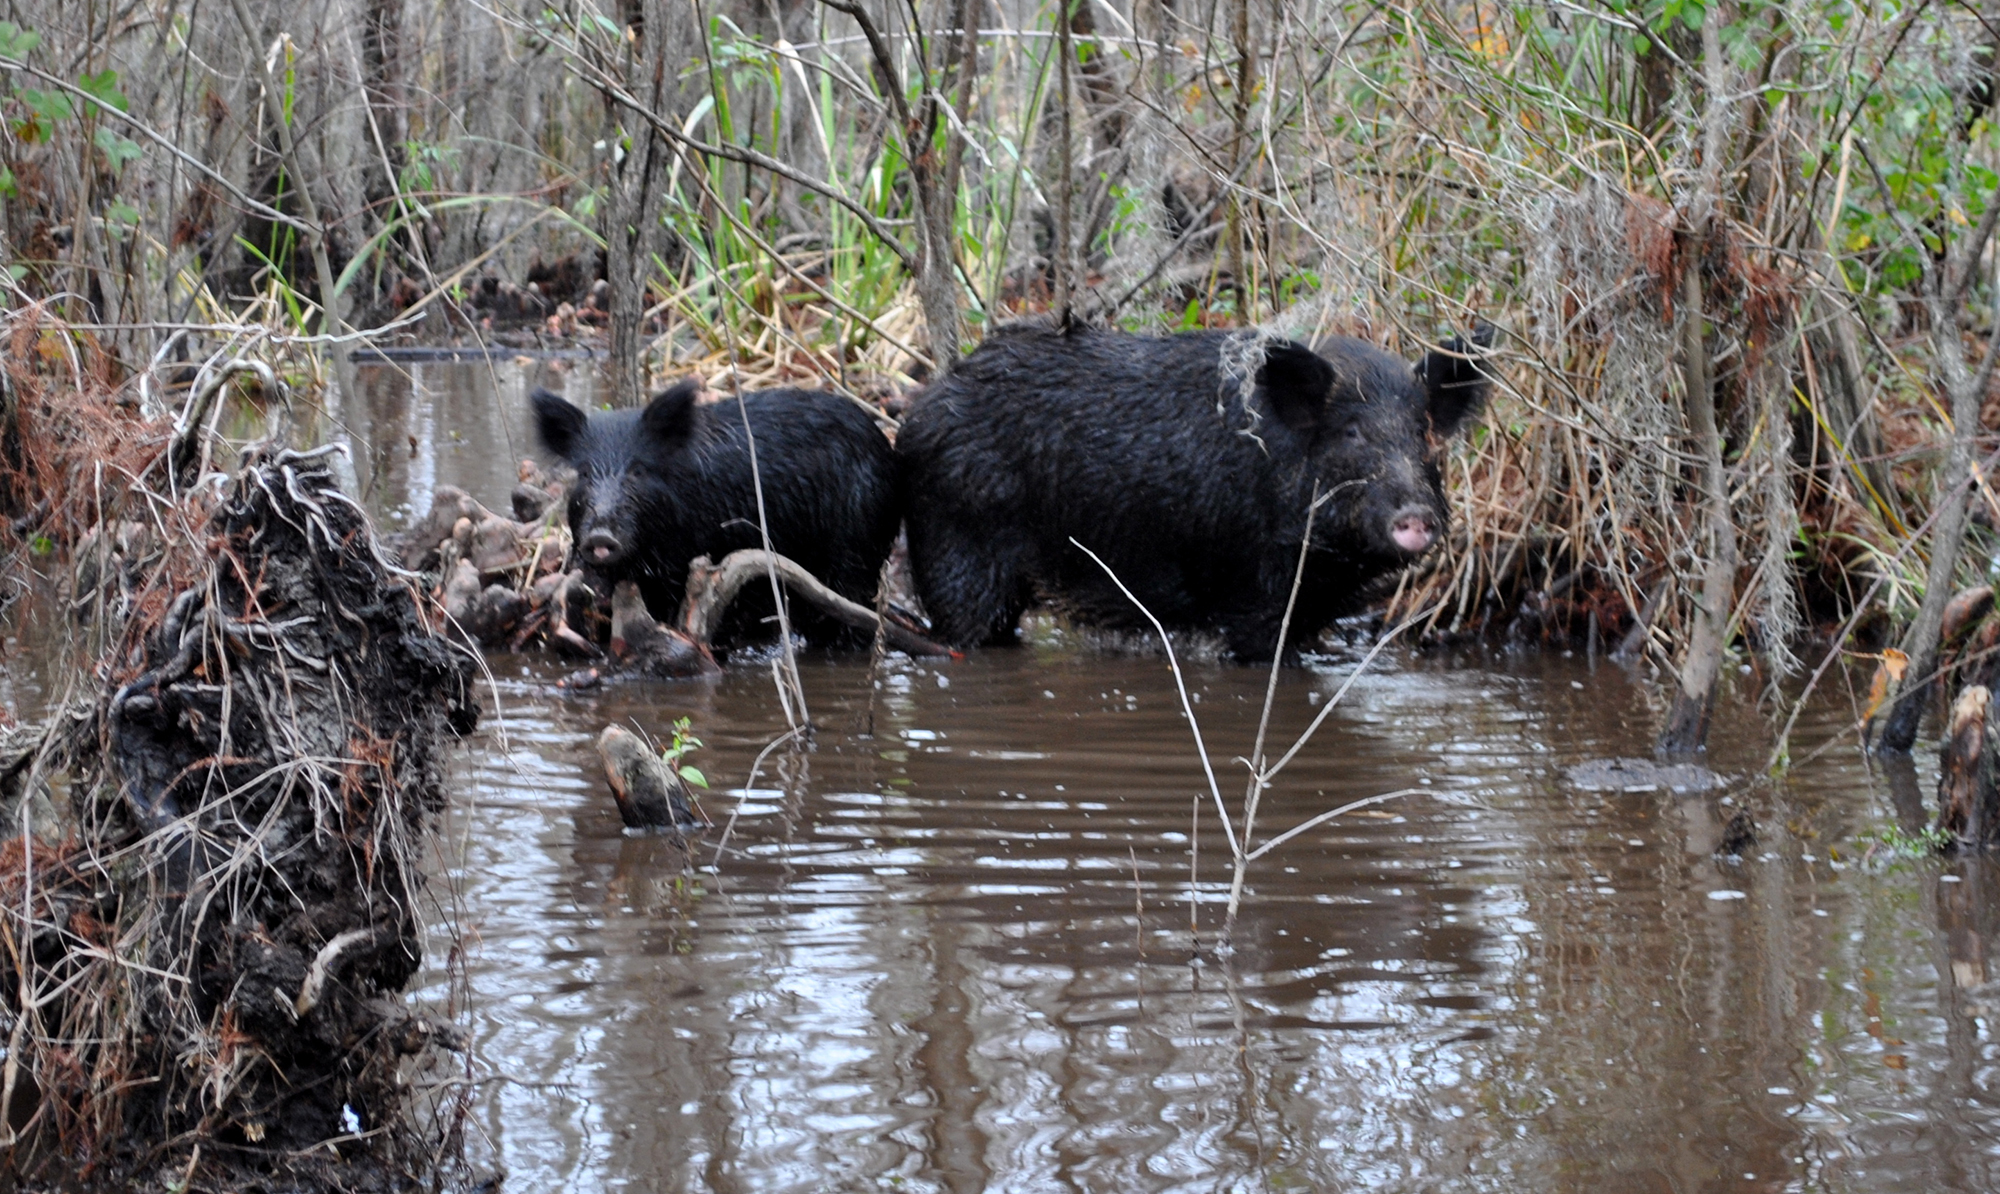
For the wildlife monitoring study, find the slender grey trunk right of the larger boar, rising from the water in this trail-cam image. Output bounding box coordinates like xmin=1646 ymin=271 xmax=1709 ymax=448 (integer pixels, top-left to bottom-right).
xmin=1660 ymin=12 xmax=1736 ymax=754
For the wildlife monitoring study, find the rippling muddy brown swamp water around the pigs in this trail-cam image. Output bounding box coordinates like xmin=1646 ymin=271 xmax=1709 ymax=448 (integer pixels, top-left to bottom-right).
xmin=11 ymin=364 xmax=2000 ymax=1192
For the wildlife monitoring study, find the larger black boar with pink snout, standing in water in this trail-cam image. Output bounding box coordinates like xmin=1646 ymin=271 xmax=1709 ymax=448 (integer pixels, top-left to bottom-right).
xmin=896 ymin=324 xmax=1486 ymax=660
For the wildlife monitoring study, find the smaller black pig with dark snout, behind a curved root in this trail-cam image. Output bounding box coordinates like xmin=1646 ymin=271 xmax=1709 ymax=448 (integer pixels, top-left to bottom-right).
xmin=530 ymin=380 xmax=902 ymax=638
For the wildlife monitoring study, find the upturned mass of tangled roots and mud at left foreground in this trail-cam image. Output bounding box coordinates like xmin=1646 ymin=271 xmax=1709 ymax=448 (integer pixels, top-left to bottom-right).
xmin=0 ymin=450 xmax=478 ymax=1188
